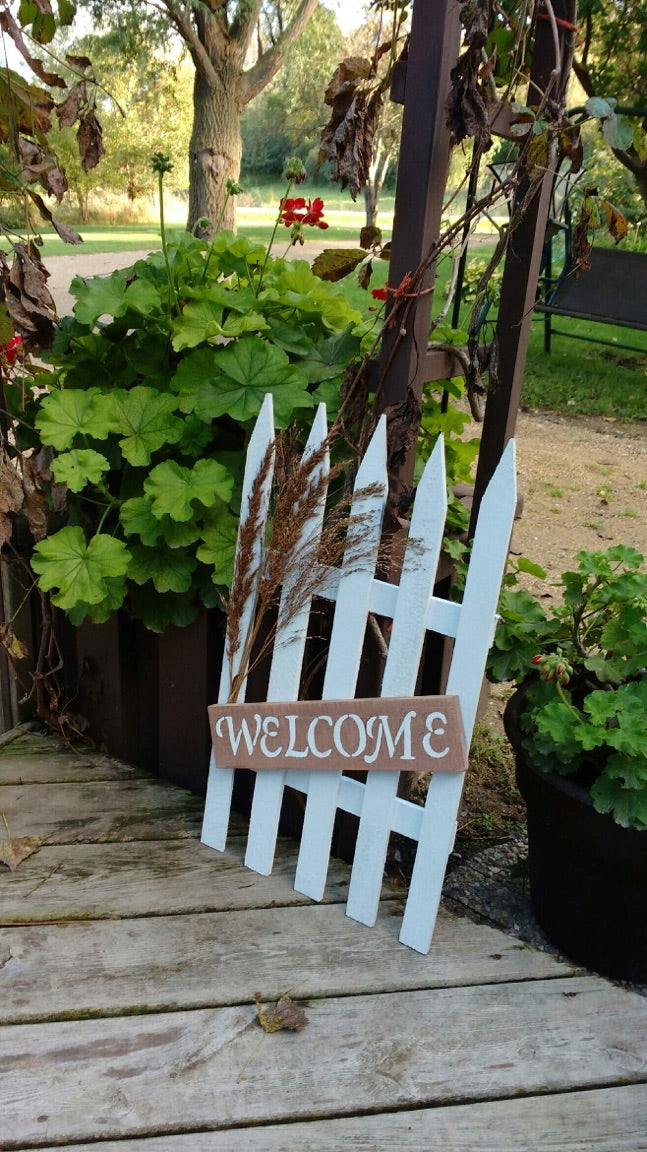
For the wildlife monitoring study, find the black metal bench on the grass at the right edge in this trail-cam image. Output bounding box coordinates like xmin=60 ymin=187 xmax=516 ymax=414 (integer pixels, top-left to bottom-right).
xmin=535 ymin=248 xmax=647 ymax=353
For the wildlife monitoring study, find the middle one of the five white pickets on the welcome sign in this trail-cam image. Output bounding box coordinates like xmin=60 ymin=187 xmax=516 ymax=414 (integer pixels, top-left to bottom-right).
xmin=295 ymin=417 xmax=388 ymax=900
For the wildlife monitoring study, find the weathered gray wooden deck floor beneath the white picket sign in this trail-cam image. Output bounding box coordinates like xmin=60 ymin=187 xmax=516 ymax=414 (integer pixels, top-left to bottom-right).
xmin=0 ymin=737 xmax=647 ymax=1152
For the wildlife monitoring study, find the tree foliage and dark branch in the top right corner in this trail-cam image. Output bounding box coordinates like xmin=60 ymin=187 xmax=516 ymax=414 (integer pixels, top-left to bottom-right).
xmin=573 ymin=0 xmax=647 ymax=205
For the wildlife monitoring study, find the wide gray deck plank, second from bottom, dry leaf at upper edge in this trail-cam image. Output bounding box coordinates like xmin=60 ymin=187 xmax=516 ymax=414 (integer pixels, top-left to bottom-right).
xmin=0 ymin=977 xmax=647 ymax=1152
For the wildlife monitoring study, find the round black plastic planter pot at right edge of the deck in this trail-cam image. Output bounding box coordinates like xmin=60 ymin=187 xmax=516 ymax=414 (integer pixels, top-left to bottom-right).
xmin=505 ymin=696 xmax=647 ymax=983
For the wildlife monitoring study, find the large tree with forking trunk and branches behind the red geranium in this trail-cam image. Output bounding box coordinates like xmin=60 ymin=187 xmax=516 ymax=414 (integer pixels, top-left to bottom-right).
xmin=83 ymin=0 xmax=319 ymax=228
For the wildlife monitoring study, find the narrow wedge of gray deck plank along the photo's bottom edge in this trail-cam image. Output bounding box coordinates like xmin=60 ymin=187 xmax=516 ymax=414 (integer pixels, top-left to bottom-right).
xmin=23 ymin=1084 xmax=647 ymax=1152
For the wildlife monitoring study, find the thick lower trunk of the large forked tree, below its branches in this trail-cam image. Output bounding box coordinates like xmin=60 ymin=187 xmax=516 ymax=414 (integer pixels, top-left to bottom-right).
xmin=187 ymin=68 xmax=243 ymax=235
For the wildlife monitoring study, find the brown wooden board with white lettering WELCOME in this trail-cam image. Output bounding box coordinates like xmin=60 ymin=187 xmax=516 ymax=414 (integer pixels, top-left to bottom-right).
xmin=208 ymin=696 xmax=467 ymax=772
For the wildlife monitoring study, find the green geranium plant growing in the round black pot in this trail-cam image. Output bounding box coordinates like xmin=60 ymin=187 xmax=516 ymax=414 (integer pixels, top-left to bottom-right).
xmin=488 ymin=545 xmax=647 ymax=829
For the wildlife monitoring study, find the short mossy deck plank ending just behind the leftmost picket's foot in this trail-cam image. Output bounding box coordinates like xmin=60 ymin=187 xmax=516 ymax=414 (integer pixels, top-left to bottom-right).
xmin=0 ymin=779 xmax=204 ymax=843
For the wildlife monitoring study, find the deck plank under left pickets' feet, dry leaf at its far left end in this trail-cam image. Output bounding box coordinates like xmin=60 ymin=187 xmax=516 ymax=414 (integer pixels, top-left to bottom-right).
xmin=0 ymin=826 xmax=349 ymax=925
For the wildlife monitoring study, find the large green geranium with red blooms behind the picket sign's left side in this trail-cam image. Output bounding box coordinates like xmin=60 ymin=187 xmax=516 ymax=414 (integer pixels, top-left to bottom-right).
xmin=14 ymin=153 xmax=364 ymax=631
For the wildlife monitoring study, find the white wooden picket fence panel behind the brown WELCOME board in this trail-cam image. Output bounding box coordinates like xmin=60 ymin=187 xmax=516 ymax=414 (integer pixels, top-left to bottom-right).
xmin=201 ymin=395 xmax=516 ymax=953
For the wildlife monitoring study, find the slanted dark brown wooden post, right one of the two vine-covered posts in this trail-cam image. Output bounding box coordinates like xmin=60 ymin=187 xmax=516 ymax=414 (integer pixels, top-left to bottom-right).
xmin=470 ymin=0 xmax=577 ymax=535
